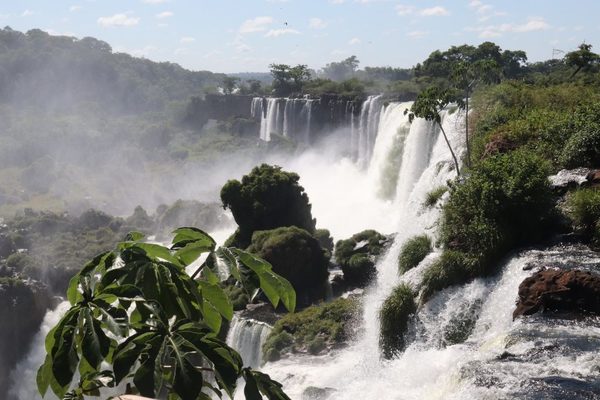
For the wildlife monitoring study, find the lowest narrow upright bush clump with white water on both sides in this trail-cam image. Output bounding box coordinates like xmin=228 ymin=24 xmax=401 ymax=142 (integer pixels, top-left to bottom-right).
xmin=379 ymin=284 xmax=417 ymax=359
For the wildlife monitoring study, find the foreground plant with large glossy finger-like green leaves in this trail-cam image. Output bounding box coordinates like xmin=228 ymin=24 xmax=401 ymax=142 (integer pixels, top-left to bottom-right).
xmin=37 ymin=228 xmax=296 ymax=400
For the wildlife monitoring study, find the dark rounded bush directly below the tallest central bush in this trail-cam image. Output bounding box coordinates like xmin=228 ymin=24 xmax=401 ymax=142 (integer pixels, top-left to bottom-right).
xmin=248 ymin=226 xmax=329 ymax=303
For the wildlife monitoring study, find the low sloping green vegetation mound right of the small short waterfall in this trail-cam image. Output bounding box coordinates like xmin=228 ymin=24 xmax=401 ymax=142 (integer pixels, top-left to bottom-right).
xmin=263 ymin=298 xmax=359 ymax=361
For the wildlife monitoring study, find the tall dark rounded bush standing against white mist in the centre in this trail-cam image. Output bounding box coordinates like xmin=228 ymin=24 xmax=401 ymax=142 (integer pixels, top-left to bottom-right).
xmin=221 ymin=164 xmax=315 ymax=248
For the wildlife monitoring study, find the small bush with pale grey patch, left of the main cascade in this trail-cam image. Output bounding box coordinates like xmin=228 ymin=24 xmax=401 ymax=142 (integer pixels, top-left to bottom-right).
xmin=335 ymin=230 xmax=389 ymax=287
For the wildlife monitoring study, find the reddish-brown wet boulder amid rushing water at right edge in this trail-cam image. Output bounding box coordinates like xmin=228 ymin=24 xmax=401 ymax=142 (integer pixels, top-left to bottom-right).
xmin=513 ymin=269 xmax=600 ymax=318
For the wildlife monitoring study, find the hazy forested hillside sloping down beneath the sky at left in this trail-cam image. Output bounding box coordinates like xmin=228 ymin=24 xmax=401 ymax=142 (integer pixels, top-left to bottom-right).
xmin=0 ymin=27 xmax=223 ymax=114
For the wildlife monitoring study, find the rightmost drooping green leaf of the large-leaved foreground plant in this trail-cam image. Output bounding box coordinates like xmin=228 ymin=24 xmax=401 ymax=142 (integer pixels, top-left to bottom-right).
xmin=232 ymin=249 xmax=296 ymax=312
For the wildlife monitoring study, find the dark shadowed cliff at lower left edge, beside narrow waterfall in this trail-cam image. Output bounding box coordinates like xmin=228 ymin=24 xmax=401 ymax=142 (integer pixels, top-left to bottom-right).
xmin=0 ymin=278 xmax=50 ymax=399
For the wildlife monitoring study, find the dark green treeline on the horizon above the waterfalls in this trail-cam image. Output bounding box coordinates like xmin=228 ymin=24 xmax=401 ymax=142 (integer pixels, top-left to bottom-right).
xmin=230 ymin=42 xmax=598 ymax=99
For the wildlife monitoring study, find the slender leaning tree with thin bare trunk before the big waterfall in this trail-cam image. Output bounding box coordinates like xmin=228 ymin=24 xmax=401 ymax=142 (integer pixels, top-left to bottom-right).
xmin=404 ymin=86 xmax=460 ymax=176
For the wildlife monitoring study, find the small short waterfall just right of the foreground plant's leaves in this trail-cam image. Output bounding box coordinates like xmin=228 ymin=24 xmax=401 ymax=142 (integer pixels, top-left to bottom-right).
xmin=227 ymin=315 xmax=271 ymax=368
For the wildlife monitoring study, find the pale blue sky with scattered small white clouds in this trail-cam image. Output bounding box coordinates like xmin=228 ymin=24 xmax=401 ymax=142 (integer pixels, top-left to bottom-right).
xmin=0 ymin=0 xmax=600 ymax=72
